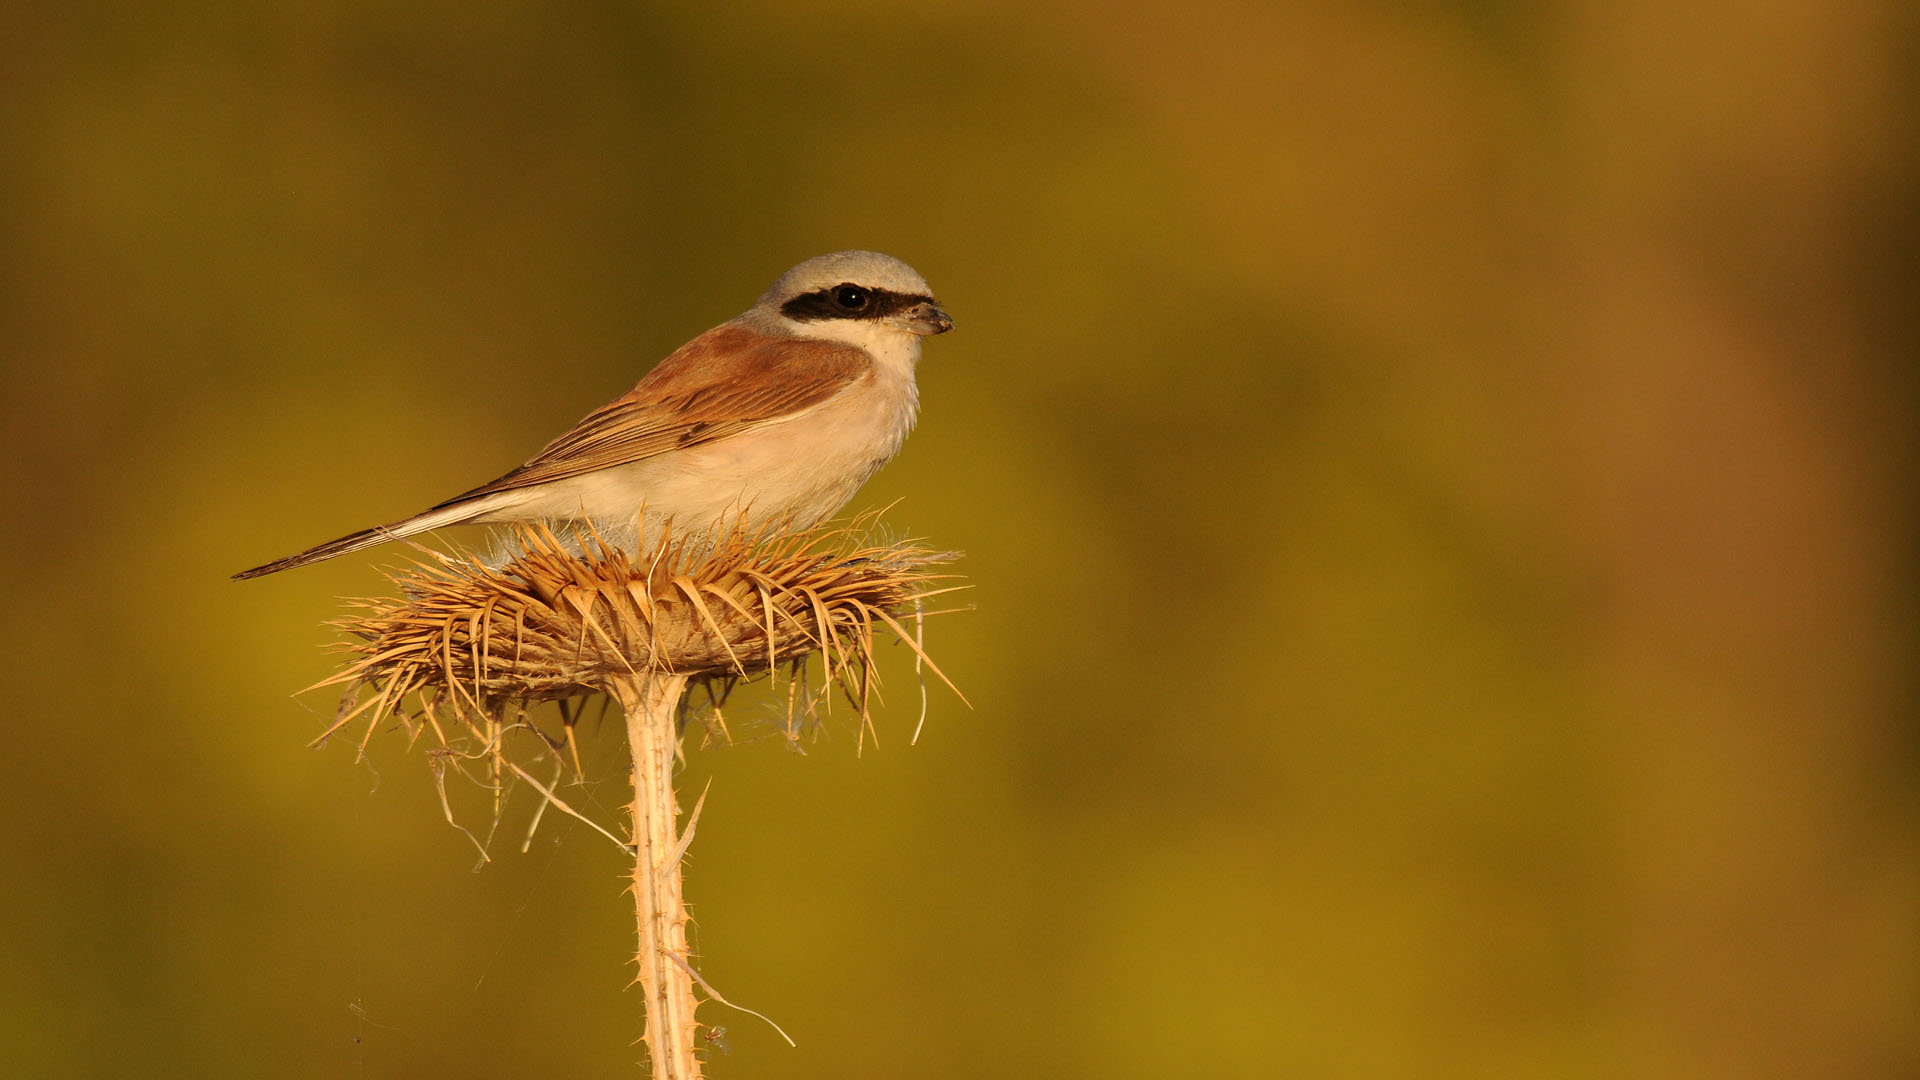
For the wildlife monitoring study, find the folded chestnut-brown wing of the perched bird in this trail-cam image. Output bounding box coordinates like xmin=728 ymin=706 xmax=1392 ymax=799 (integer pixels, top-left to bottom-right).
xmin=434 ymin=325 xmax=872 ymax=509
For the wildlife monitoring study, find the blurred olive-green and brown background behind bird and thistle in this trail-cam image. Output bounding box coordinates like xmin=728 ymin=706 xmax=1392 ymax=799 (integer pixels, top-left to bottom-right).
xmin=0 ymin=0 xmax=1920 ymax=1080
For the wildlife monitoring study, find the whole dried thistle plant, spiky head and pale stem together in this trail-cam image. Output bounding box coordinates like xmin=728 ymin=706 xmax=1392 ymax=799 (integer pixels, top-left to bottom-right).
xmin=317 ymin=517 xmax=975 ymax=1080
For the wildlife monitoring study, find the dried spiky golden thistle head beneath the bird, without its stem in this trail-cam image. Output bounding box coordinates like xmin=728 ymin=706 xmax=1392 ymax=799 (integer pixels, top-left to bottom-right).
xmin=315 ymin=517 xmax=962 ymax=755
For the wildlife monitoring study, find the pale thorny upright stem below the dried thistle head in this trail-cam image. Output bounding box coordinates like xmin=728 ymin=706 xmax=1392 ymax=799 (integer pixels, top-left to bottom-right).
xmin=609 ymin=675 xmax=701 ymax=1080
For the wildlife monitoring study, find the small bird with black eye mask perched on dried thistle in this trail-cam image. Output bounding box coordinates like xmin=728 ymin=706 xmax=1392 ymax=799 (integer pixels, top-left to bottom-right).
xmin=232 ymin=252 xmax=954 ymax=580
